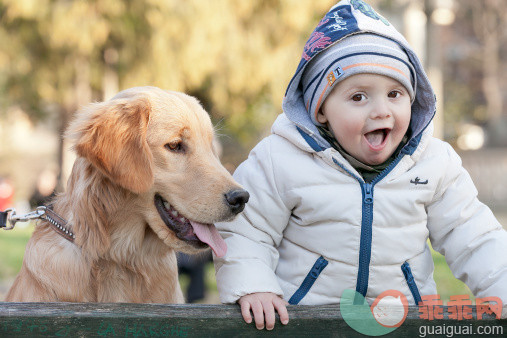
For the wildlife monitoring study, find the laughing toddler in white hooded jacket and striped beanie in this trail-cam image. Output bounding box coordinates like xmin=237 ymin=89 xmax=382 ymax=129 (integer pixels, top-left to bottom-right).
xmin=215 ymin=0 xmax=507 ymax=329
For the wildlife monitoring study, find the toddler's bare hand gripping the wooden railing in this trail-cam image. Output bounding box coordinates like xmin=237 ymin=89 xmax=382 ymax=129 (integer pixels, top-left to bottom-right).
xmin=238 ymin=292 xmax=289 ymax=330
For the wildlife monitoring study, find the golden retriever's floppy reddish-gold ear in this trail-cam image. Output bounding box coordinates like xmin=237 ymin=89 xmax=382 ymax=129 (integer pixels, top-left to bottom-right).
xmin=67 ymin=95 xmax=153 ymax=193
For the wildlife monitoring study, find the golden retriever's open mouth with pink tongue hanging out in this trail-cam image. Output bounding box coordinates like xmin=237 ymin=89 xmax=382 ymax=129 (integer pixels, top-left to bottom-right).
xmin=155 ymin=194 xmax=227 ymax=257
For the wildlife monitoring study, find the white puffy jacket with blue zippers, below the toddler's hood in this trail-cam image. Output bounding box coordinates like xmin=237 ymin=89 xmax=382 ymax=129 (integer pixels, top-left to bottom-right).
xmin=215 ymin=114 xmax=507 ymax=305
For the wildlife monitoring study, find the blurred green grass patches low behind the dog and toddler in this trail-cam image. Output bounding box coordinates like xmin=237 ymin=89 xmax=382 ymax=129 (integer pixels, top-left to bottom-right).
xmin=0 ymin=226 xmax=473 ymax=304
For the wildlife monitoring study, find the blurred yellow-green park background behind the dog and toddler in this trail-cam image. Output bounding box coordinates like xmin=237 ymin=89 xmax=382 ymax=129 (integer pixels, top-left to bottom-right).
xmin=0 ymin=0 xmax=507 ymax=302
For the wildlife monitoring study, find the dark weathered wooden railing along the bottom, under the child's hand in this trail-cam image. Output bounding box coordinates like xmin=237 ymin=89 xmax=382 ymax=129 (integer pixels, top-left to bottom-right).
xmin=0 ymin=302 xmax=507 ymax=338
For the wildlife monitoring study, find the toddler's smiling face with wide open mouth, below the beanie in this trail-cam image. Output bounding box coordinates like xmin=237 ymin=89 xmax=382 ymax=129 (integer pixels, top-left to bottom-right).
xmin=317 ymin=74 xmax=411 ymax=165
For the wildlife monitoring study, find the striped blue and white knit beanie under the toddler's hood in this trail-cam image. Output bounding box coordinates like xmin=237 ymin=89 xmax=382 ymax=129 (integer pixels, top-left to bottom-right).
xmin=301 ymin=33 xmax=417 ymax=125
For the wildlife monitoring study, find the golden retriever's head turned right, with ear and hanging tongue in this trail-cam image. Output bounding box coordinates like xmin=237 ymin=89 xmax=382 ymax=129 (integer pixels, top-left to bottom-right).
xmin=69 ymin=87 xmax=249 ymax=256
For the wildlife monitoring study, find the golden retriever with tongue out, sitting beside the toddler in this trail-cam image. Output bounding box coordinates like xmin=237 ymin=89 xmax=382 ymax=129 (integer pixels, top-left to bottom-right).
xmin=6 ymin=87 xmax=249 ymax=303
